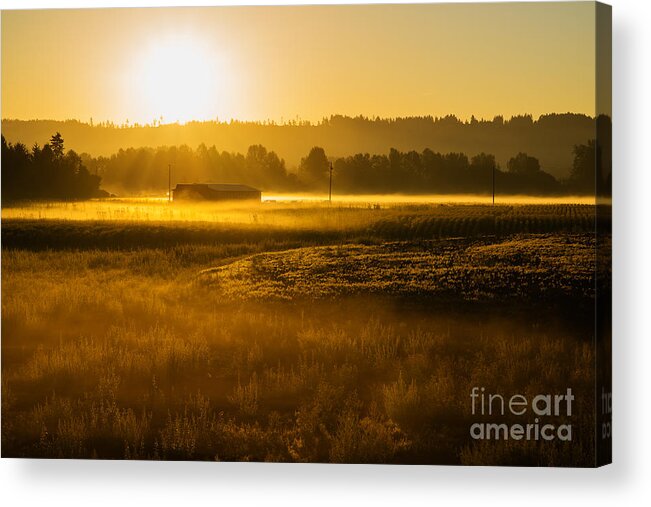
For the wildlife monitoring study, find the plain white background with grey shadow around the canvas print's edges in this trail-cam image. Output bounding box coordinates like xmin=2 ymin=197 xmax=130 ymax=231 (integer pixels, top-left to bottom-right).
xmin=0 ymin=0 xmax=651 ymax=507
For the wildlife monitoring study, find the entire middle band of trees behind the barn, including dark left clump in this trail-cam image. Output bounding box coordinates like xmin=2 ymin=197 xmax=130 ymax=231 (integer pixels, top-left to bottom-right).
xmin=2 ymin=132 xmax=611 ymax=199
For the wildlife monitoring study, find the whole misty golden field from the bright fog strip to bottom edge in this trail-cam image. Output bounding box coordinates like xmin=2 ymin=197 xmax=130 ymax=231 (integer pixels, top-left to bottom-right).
xmin=2 ymin=200 xmax=610 ymax=466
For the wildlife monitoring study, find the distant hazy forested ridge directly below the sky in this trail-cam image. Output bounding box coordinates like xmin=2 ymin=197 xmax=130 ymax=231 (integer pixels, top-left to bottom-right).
xmin=2 ymin=113 xmax=608 ymax=178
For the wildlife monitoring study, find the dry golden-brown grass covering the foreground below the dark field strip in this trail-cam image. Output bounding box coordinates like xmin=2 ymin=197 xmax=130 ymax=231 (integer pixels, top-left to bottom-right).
xmin=2 ymin=201 xmax=594 ymax=465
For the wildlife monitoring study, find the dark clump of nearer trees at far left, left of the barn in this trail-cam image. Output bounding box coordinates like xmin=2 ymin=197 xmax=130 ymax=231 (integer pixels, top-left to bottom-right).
xmin=1 ymin=132 xmax=107 ymax=201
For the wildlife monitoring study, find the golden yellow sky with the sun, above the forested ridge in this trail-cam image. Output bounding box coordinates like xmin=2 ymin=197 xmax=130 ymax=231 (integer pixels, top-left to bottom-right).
xmin=2 ymin=2 xmax=595 ymax=123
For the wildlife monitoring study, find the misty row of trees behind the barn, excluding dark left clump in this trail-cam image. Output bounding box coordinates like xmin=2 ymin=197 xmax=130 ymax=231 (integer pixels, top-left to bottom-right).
xmin=83 ymin=141 xmax=611 ymax=195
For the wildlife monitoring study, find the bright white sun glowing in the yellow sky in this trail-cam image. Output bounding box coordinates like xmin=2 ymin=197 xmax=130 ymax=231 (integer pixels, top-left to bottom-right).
xmin=133 ymin=35 xmax=223 ymax=123
